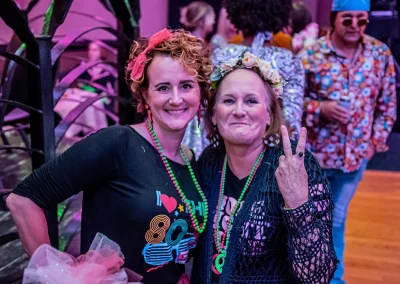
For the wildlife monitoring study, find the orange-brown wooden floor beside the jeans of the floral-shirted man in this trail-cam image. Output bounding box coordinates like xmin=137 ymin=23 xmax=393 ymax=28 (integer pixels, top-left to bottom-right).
xmin=345 ymin=171 xmax=400 ymax=284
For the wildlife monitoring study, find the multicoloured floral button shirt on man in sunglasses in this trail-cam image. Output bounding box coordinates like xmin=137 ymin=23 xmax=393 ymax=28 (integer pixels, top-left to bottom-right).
xmin=299 ymin=34 xmax=397 ymax=172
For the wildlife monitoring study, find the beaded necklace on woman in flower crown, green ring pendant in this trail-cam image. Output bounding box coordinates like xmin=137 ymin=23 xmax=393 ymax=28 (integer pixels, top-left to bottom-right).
xmin=212 ymin=149 xmax=265 ymax=274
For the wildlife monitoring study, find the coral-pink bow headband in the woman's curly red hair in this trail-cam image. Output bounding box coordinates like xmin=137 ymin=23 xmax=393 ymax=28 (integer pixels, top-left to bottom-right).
xmin=127 ymin=29 xmax=172 ymax=81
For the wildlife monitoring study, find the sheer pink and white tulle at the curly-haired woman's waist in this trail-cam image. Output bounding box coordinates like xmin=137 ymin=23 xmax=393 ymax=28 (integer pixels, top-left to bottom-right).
xmin=22 ymin=233 xmax=142 ymax=284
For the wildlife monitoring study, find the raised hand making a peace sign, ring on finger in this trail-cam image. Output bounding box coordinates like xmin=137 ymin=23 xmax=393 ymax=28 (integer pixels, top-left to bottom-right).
xmin=275 ymin=126 xmax=308 ymax=209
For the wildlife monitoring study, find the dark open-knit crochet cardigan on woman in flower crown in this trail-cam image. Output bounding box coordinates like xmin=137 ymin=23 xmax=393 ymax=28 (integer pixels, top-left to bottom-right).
xmin=191 ymin=146 xmax=337 ymax=284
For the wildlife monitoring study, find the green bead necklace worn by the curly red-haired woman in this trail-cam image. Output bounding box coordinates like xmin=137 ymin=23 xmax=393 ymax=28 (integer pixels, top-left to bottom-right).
xmin=147 ymin=120 xmax=208 ymax=234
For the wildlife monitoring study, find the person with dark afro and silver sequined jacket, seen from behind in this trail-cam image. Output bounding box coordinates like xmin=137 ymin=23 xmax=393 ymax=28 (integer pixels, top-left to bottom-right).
xmin=211 ymin=0 xmax=304 ymax=136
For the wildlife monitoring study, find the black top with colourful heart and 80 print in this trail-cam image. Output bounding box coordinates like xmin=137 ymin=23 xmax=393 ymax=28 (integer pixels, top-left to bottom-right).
xmin=14 ymin=126 xmax=204 ymax=283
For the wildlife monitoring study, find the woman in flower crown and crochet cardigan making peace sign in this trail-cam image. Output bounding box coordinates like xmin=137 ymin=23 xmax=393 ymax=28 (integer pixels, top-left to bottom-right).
xmin=191 ymin=52 xmax=337 ymax=284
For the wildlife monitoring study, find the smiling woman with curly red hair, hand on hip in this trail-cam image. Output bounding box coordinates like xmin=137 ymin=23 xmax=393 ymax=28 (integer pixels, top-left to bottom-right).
xmin=7 ymin=29 xmax=211 ymax=283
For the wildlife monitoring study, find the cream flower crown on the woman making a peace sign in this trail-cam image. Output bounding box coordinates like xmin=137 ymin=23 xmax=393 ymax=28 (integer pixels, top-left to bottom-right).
xmin=210 ymin=51 xmax=285 ymax=98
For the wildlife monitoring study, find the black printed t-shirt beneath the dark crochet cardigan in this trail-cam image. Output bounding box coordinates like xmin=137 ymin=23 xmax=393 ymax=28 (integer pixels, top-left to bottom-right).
xmin=212 ymin=166 xmax=247 ymax=283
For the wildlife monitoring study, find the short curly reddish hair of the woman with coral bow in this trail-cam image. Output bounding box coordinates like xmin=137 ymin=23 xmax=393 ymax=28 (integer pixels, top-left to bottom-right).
xmin=127 ymin=29 xmax=212 ymax=113
